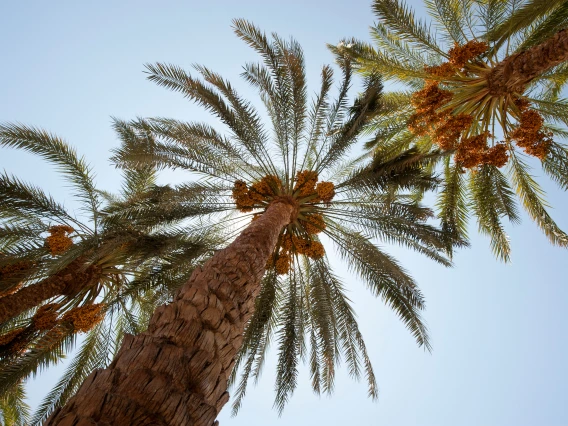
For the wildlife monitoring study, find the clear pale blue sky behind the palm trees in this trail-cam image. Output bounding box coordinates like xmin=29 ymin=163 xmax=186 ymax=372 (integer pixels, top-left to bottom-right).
xmin=0 ymin=0 xmax=568 ymax=426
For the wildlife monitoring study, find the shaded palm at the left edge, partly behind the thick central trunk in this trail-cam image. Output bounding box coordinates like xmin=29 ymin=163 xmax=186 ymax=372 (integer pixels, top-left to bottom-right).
xmin=0 ymin=123 xmax=218 ymax=425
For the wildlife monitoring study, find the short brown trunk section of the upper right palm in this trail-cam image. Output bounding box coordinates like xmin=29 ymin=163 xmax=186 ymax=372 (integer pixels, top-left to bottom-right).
xmin=487 ymin=30 xmax=568 ymax=96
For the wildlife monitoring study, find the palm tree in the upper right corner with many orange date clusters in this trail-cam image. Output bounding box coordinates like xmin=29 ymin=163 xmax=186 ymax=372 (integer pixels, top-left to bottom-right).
xmin=338 ymin=0 xmax=568 ymax=261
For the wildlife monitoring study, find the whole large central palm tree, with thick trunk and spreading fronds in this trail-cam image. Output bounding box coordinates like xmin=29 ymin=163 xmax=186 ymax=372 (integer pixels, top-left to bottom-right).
xmin=38 ymin=20 xmax=454 ymax=426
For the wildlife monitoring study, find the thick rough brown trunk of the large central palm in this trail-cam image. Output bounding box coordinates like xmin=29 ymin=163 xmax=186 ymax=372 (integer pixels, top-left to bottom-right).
xmin=46 ymin=200 xmax=294 ymax=426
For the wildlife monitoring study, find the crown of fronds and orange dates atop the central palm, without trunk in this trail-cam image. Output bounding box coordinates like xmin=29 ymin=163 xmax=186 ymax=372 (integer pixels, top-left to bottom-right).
xmin=114 ymin=20 xmax=455 ymax=412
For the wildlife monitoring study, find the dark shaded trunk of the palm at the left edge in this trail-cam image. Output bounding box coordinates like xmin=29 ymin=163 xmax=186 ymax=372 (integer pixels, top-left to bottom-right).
xmin=0 ymin=259 xmax=98 ymax=324
